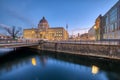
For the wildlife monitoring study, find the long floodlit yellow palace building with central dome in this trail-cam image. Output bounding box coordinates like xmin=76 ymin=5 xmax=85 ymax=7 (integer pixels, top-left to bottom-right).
xmin=23 ymin=17 xmax=68 ymax=40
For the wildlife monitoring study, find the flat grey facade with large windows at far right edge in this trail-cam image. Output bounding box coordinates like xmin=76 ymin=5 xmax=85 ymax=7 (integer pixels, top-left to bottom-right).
xmin=103 ymin=0 xmax=120 ymax=39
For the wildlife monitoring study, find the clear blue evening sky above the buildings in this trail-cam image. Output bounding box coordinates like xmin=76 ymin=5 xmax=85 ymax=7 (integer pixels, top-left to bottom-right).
xmin=0 ymin=0 xmax=118 ymax=33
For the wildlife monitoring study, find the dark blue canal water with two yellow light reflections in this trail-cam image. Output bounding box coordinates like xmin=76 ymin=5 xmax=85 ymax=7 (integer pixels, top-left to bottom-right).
xmin=0 ymin=48 xmax=120 ymax=80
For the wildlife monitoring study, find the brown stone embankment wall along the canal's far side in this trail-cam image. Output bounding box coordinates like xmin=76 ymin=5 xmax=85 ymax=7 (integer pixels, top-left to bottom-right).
xmin=37 ymin=42 xmax=120 ymax=59
